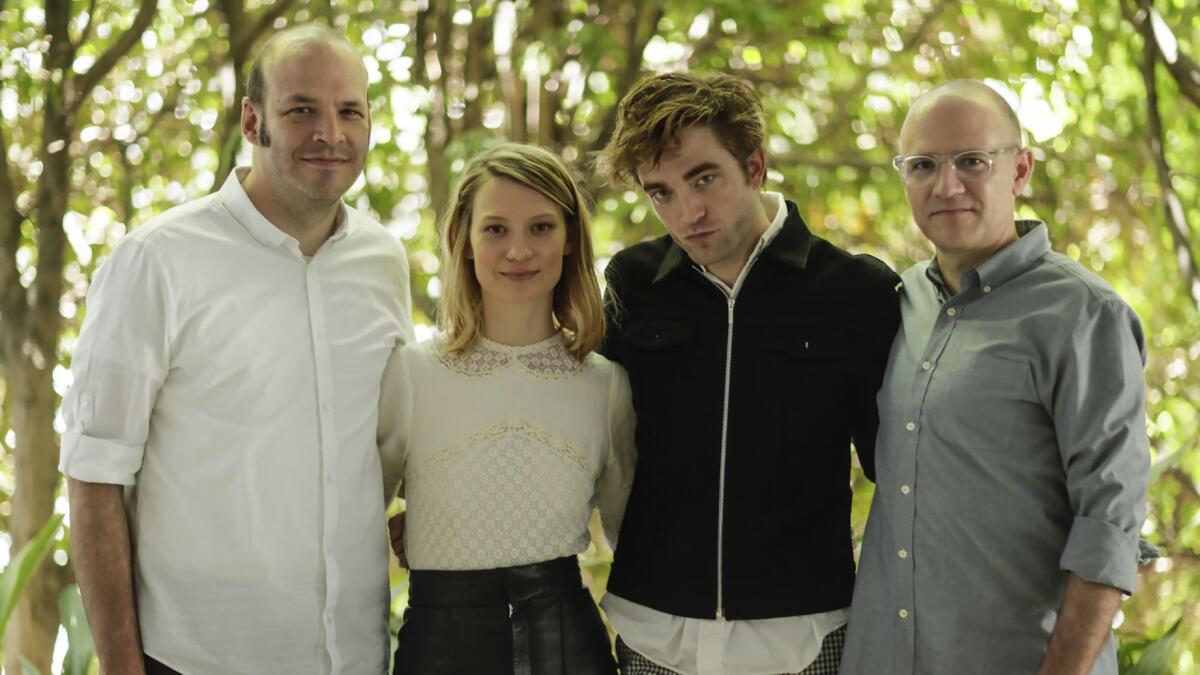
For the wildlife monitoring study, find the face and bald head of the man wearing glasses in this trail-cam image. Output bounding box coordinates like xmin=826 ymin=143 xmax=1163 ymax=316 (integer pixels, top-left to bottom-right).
xmin=900 ymin=96 xmax=1033 ymax=263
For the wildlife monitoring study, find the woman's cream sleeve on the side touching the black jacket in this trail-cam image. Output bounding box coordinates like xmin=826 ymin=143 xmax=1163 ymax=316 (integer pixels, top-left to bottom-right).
xmin=595 ymin=363 xmax=637 ymax=548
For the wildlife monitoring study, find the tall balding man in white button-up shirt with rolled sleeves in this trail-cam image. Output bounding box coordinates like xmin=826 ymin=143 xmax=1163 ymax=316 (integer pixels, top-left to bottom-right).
xmin=60 ymin=26 xmax=412 ymax=675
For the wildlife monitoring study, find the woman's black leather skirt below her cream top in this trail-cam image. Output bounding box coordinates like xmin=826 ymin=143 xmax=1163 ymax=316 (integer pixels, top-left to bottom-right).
xmin=394 ymin=556 xmax=617 ymax=675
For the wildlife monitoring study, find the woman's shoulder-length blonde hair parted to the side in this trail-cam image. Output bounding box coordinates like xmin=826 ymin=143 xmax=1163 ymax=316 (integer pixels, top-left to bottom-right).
xmin=438 ymin=143 xmax=604 ymax=359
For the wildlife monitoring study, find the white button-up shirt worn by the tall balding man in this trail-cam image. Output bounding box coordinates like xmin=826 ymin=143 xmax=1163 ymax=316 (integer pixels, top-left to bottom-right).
xmin=60 ymin=169 xmax=412 ymax=675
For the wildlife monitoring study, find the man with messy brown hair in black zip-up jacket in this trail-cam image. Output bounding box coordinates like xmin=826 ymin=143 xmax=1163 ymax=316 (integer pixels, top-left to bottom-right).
xmin=599 ymin=73 xmax=899 ymax=675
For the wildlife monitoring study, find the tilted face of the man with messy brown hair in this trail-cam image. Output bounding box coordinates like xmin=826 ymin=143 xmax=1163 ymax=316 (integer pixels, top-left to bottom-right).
xmin=637 ymin=125 xmax=768 ymax=283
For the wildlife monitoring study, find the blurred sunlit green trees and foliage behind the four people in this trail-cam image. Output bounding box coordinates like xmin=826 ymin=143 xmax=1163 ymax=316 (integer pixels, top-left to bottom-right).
xmin=0 ymin=0 xmax=1200 ymax=674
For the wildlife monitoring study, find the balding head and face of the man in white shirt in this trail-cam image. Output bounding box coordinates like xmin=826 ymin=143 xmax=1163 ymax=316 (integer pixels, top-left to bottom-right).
xmin=242 ymin=42 xmax=371 ymax=208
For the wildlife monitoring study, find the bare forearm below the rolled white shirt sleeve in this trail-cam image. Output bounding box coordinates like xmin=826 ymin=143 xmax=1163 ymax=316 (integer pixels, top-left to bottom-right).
xmin=67 ymin=478 xmax=145 ymax=675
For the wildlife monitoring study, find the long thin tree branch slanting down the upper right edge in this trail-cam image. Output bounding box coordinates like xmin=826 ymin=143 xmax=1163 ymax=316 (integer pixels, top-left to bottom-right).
xmin=1138 ymin=0 xmax=1200 ymax=307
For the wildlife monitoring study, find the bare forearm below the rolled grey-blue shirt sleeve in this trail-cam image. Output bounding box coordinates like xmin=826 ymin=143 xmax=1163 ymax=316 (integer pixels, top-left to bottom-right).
xmin=1038 ymin=572 xmax=1121 ymax=675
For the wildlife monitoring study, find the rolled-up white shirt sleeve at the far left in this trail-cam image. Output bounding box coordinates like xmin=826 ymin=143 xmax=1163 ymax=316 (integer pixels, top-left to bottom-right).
xmin=59 ymin=240 xmax=175 ymax=485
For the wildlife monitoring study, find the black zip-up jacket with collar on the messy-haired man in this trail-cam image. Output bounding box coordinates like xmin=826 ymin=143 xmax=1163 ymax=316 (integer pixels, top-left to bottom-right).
xmin=601 ymin=202 xmax=900 ymax=620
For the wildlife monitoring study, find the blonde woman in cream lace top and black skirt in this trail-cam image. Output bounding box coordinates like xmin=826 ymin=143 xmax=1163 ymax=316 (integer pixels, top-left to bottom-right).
xmin=379 ymin=144 xmax=634 ymax=675
